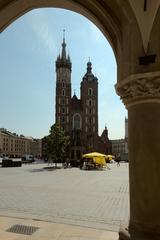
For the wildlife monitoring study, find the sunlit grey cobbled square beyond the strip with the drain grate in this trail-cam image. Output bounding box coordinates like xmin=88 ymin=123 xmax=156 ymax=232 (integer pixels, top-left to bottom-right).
xmin=0 ymin=163 xmax=129 ymax=231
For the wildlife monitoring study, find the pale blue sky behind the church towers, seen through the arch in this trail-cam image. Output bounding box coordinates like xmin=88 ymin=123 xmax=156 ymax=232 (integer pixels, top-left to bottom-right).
xmin=0 ymin=8 xmax=127 ymax=139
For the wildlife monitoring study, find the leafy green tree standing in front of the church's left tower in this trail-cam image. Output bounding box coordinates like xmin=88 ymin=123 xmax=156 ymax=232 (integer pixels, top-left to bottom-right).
xmin=46 ymin=123 xmax=70 ymax=164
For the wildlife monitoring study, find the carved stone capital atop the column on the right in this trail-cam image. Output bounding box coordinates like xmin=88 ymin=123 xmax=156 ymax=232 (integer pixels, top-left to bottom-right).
xmin=115 ymin=71 xmax=160 ymax=108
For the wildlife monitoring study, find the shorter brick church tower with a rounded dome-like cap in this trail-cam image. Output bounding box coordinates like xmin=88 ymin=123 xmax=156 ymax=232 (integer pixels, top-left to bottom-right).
xmin=81 ymin=61 xmax=98 ymax=151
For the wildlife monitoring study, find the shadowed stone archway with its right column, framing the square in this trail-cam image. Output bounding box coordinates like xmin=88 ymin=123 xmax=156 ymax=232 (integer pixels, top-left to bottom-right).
xmin=0 ymin=0 xmax=160 ymax=240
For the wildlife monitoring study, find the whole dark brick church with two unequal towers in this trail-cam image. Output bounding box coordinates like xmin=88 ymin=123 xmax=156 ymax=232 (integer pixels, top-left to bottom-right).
xmin=55 ymin=34 xmax=111 ymax=160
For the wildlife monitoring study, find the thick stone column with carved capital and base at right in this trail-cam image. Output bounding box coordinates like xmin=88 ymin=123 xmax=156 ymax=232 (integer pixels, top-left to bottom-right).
xmin=116 ymin=72 xmax=160 ymax=240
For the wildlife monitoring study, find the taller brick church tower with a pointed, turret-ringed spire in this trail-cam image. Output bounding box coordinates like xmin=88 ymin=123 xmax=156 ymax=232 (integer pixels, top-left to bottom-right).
xmin=55 ymin=32 xmax=72 ymax=133
